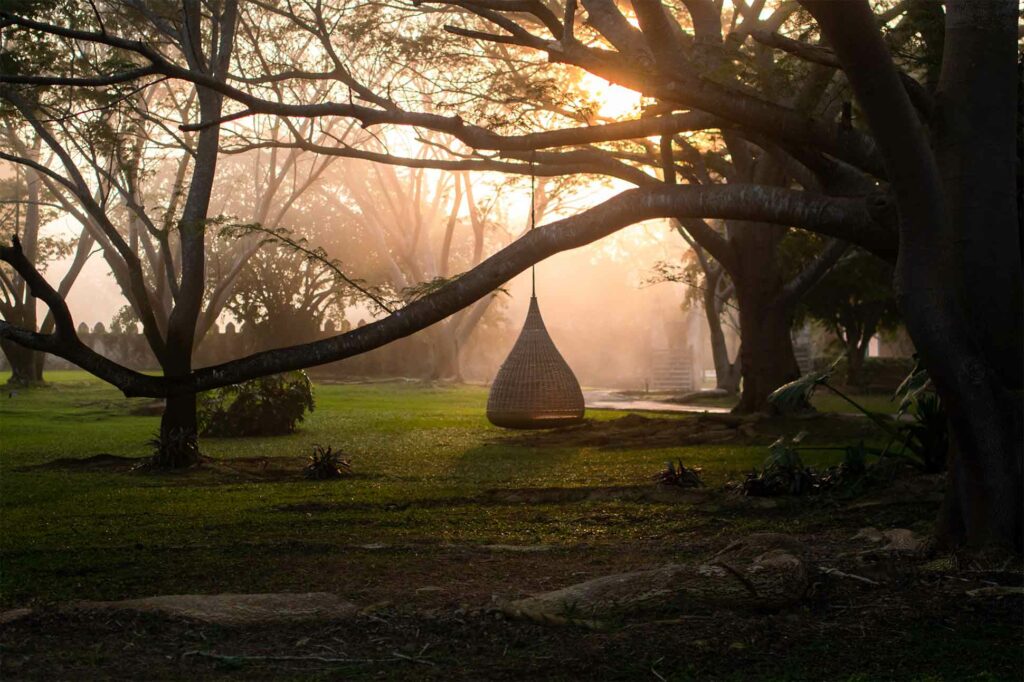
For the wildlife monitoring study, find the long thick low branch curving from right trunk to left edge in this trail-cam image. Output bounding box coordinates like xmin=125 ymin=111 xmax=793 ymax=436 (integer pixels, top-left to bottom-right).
xmin=0 ymin=185 xmax=893 ymax=397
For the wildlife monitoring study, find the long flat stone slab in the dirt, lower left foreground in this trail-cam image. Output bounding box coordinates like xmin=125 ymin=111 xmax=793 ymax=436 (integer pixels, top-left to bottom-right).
xmin=72 ymin=592 xmax=358 ymax=626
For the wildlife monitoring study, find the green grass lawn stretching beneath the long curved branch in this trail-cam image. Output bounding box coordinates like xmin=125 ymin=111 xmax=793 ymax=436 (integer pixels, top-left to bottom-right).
xmin=0 ymin=372 xmax=790 ymax=605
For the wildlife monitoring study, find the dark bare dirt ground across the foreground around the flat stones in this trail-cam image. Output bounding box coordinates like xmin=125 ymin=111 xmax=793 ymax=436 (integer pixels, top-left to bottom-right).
xmin=0 ymin=488 xmax=1024 ymax=680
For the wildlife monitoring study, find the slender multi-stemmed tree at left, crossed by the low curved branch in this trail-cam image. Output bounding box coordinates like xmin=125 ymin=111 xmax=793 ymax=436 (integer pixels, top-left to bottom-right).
xmin=0 ymin=0 xmax=238 ymax=464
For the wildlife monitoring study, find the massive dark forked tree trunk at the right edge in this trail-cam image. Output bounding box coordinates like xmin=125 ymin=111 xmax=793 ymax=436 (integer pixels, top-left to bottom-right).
xmin=804 ymin=0 xmax=1024 ymax=550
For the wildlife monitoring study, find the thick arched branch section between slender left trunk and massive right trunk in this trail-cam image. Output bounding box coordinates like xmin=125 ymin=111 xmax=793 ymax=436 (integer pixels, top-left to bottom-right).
xmin=178 ymin=185 xmax=891 ymax=392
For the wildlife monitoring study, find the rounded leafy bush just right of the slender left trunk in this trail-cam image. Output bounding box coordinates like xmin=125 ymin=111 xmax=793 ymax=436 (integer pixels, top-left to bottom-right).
xmin=199 ymin=372 xmax=313 ymax=438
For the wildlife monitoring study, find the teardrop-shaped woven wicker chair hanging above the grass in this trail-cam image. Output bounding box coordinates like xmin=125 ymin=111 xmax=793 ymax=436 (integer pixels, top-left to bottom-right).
xmin=487 ymin=296 xmax=584 ymax=429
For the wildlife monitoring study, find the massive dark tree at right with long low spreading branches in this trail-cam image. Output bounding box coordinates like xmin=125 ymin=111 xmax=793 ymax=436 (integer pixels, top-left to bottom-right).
xmin=0 ymin=0 xmax=1024 ymax=548
